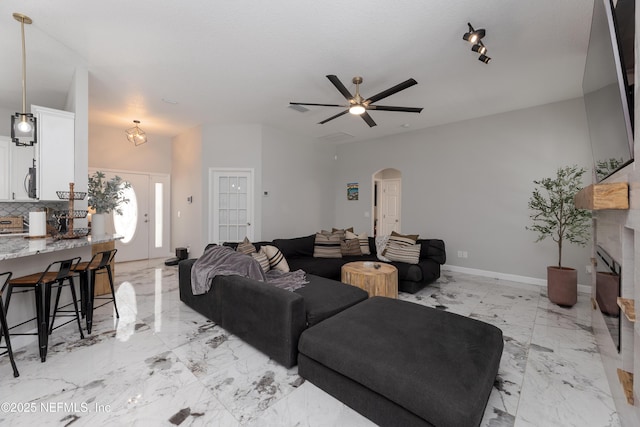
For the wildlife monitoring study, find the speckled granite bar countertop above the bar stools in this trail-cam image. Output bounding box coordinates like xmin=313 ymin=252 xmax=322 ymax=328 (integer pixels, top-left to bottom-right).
xmin=0 ymin=234 xmax=122 ymax=261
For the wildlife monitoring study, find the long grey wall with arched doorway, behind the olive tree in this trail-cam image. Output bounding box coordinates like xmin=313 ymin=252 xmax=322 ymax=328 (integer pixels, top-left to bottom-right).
xmin=335 ymin=98 xmax=593 ymax=284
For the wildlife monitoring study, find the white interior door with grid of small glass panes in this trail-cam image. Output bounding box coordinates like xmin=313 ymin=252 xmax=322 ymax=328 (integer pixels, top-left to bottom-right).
xmin=209 ymin=169 xmax=254 ymax=243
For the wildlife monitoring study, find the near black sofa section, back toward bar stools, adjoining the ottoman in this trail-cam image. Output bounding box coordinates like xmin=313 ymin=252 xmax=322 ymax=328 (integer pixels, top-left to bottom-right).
xmin=178 ymin=259 xmax=369 ymax=367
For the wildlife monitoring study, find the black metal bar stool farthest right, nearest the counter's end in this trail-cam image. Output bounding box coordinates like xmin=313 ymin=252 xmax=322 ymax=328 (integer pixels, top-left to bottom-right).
xmin=73 ymin=249 xmax=120 ymax=334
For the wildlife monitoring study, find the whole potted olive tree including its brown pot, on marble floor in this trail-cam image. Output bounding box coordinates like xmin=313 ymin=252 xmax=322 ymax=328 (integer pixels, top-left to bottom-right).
xmin=527 ymin=165 xmax=591 ymax=306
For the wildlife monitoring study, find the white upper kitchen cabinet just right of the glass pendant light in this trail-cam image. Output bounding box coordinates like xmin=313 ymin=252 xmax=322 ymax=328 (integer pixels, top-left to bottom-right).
xmin=31 ymin=105 xmax=75 ymax=200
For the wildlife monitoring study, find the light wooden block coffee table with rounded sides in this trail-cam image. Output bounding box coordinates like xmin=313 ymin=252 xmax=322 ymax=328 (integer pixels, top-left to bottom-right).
xmin=342 ymin=261 xmax=398 ymax=298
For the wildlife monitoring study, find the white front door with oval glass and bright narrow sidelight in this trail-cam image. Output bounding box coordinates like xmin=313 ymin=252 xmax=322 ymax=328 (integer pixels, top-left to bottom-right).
xmin=90 ymin=170 xmax=170 ymax=262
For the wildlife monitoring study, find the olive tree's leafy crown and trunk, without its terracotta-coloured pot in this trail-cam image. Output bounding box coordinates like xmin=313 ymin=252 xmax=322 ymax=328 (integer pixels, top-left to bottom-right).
xmin=526 ymin=165 xmax=591 ymax=268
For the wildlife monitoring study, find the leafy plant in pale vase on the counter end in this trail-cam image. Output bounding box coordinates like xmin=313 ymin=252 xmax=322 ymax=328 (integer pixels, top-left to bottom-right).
xmin=87 ymin=171 xmax=131 ymax=236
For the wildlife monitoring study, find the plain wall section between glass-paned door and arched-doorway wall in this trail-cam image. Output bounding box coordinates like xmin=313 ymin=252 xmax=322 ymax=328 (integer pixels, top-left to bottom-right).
xmin=262 ymin=127 xmax=337 ymax=240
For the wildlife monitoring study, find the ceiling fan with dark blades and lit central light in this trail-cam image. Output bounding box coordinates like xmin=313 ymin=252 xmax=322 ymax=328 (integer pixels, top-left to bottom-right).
xmin=289 ymin=74 xmax=422 ymax=127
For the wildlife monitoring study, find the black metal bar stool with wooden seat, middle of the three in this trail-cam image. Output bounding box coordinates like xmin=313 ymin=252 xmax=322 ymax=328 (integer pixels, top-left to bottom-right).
xmin=3 ymin=257 xmax=84 ymax=362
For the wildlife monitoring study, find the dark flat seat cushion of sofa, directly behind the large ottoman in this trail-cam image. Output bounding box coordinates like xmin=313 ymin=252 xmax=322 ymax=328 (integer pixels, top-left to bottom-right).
xmin=294 ymin=274 xmax=369 ymax=326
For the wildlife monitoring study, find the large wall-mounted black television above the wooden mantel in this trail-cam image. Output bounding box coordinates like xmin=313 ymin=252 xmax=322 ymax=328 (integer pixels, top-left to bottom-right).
xmin=582 ymin=0 xmax=635 ymax=182
